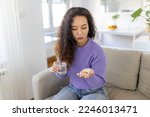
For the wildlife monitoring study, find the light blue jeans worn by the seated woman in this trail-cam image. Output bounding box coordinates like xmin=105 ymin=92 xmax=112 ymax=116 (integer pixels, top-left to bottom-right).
xmin=52 ymin=85 xmax=108 ymax=100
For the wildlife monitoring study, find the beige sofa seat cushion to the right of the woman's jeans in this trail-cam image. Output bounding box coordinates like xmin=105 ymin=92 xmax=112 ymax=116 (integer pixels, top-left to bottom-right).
xmin=106 ymin=87 xmax=149 ymax=100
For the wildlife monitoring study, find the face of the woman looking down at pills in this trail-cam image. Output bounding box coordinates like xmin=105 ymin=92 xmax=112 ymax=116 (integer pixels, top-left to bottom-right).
xmin=72 ymin=16 xmax=89 ymax=46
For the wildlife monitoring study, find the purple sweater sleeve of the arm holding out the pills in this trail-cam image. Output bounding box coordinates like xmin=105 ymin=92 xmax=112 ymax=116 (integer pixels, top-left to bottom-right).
xmin=85 ymin=49 xmax=106 ymax=88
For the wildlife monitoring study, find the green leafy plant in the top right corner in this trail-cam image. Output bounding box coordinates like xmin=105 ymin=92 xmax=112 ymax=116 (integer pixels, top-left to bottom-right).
xmin=131 ymin=0 xmax=150 ymax=32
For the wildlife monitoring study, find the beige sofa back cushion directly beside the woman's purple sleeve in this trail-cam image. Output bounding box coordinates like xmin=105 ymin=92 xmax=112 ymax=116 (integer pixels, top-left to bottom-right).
xmin=103 ymin=47 xmax=141 ymax=90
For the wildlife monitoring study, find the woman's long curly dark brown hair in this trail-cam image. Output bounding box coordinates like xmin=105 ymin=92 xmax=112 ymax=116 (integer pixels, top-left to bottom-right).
xmin=55 ymin=7 xmax=96 ymax=66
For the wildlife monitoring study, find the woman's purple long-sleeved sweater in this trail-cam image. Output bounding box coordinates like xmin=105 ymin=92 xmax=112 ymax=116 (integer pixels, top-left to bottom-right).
xmin=57 ymin=39 xmax=106 ymax=89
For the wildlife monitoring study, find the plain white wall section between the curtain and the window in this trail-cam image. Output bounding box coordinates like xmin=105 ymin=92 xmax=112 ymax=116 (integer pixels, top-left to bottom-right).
xmin=18 ymin=0 xmax=47 ymax=99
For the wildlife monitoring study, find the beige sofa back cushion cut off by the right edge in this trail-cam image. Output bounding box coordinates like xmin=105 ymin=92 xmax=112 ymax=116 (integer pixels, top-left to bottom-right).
xmin=138 ymin=52 xmax=150 ymax=98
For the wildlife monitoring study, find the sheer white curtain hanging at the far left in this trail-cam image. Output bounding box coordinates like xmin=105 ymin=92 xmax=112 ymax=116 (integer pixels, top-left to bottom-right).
xmin=0 ymin=0 xmax=26 ymax=99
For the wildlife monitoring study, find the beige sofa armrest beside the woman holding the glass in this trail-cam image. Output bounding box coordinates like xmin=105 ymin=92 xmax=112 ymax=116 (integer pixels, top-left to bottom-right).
xmin=32 ymin=69 xmax=68 ymax=100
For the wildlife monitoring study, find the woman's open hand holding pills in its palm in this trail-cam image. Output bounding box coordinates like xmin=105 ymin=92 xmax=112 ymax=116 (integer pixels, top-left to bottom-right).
xmin=77 ymin=68 xmax=95 ymax=78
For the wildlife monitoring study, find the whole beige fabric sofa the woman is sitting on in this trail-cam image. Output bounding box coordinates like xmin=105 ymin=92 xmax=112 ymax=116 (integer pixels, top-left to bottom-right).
xmin=32 ymin=47 xmax=150 ymax=100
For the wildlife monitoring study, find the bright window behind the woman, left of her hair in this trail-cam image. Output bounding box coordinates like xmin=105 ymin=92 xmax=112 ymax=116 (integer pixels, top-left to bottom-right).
xmin=42 ymin=0 xmax=68 ymax=37
